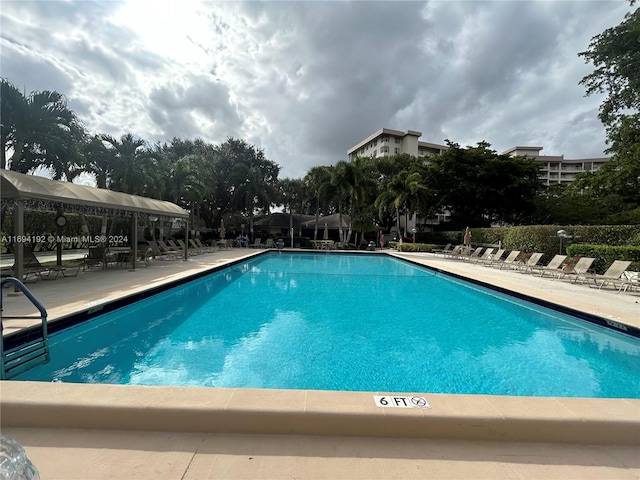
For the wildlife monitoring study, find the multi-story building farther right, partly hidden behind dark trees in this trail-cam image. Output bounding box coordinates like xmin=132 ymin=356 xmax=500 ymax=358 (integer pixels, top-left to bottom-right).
xmin=503 ymin=147 xmax=609 ymax=186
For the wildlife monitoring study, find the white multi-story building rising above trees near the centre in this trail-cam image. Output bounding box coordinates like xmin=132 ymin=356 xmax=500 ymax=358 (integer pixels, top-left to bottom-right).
xmin=347 ymin=128 xmax=449 ymax=160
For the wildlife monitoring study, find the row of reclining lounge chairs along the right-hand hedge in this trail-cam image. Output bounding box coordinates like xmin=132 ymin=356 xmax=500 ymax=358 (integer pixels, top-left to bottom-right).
xmin=433 ymin=245 xmax=640 ymax=292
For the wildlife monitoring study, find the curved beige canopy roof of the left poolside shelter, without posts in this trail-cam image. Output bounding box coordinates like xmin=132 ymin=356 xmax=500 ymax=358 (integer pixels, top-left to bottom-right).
xmin=0 ymin=170 xmax=189 ymax=218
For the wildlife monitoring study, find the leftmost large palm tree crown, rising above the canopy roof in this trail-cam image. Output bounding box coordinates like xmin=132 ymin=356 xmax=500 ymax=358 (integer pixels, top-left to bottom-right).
xmin=0 ymin=80 xmax=82 ymax=173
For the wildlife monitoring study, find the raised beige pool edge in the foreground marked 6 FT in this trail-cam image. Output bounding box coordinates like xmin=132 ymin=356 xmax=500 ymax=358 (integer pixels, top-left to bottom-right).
xmin=0 ymin=380 xmax=640 ymax=445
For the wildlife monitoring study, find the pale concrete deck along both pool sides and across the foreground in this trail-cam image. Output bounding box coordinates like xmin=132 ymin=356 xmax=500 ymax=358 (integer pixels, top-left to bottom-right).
xmin=0 ymin=249 xmax=640 ymax=480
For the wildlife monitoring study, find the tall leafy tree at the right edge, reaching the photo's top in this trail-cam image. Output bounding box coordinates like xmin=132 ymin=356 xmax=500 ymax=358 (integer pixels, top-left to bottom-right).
xmin=573 ymin=2 xmax=640 ymax=208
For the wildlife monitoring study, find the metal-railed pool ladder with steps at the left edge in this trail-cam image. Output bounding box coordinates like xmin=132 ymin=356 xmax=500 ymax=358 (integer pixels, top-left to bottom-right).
xmin=0 ymin=277 xmax=49 ymax=380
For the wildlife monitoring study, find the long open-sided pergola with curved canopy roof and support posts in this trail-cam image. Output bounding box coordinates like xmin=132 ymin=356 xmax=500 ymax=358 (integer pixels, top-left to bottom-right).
xmin=0 ymin=170 xmax=189 ymax=278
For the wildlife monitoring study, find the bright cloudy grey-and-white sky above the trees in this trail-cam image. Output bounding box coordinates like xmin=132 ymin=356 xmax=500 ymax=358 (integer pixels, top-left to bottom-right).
xmin=0 ymin=0 xmax=631 ymax=178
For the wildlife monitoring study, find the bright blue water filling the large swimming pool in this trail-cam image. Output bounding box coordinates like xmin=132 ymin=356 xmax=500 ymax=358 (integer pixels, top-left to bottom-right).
xmin=18 ymin=253 xmax=640 ymax=398
